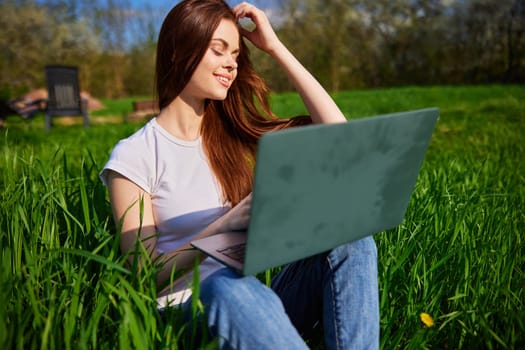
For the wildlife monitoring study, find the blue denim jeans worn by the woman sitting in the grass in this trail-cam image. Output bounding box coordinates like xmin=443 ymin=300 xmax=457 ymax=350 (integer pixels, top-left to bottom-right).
xmin=188 ymin=237 xmax=379 ymax=349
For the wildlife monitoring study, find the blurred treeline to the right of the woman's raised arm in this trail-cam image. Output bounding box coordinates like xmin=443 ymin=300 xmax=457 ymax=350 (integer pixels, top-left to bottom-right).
xmin=276 ymin=0 xmax=525 ymax=91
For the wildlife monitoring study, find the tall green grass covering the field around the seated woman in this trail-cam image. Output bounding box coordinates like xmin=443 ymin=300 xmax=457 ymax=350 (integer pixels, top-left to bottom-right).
xmin=0 ymin=86 xmax=525 ymax=349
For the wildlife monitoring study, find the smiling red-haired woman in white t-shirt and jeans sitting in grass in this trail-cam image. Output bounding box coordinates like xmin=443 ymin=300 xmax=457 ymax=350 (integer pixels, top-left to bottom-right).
xmin=101 ymin=0 xmax=379 ymax=349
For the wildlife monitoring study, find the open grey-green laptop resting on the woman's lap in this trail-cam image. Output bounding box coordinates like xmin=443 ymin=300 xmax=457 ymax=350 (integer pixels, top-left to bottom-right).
xmin=191 ymin=108 xmax=439 ymax=275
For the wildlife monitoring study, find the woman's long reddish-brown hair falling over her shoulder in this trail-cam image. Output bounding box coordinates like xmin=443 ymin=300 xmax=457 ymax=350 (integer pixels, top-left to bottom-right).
xmin=156 ymin=0 xmax=310 ymax=205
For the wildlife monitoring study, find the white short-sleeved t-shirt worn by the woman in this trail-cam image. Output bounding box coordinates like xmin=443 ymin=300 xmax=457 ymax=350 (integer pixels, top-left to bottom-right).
xmin=100 ymin=118 xmax=229 ymax=305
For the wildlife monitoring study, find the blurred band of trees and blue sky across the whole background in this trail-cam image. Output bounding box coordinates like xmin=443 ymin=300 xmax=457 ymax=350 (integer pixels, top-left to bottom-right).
xmin=0 ymin=0 xmax=525 ymax=98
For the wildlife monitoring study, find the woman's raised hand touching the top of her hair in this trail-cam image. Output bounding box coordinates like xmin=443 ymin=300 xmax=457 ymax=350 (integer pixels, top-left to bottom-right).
xmin=233 ymin=2 xmax=282 ymax=54
